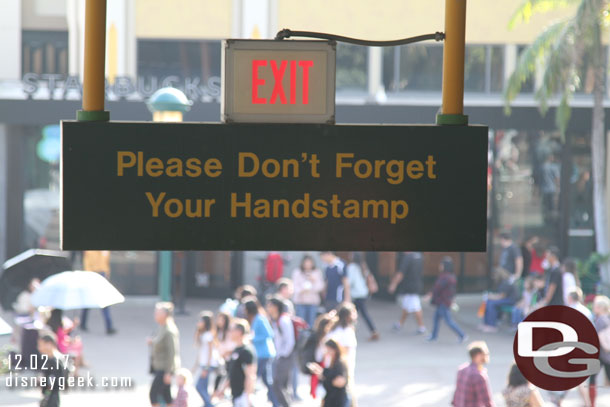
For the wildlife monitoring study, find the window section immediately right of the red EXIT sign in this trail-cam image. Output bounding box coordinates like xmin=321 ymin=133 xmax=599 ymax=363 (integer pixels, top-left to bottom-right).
xmin=337 ymin=43 xmax=368 ymax=91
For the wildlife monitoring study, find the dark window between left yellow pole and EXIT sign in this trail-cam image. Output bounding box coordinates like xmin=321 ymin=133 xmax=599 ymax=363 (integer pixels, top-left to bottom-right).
xmin=138 ymin=40 xmax=220 ymax=82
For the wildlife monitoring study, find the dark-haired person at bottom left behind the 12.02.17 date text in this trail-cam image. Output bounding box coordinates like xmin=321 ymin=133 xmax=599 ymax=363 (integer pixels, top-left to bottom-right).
xmin=38 ymin=332 xmax=66 ymax=407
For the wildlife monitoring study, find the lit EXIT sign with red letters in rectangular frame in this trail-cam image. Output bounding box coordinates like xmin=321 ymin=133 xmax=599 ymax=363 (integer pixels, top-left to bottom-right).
xmin=221 ymin=40 xmax=336 ymax=123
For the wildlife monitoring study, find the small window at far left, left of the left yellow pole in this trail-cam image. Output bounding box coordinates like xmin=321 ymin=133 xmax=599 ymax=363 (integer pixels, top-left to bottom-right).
xmin=21 ymin=30 xmax=68 ymax=75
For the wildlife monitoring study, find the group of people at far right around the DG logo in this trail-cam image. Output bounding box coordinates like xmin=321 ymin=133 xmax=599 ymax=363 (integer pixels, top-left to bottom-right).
xmin=470 ymin=233 xmax=610 ymax=407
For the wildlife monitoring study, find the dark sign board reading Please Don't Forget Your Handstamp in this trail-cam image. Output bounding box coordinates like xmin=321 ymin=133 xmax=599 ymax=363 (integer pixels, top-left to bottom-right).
xmin=61 ymin=122 xmax=488 ymax=251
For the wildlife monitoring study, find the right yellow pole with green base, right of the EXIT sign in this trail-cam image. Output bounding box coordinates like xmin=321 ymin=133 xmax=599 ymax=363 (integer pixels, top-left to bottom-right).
xmin=437 ymin=0 xmax=468 ymax=124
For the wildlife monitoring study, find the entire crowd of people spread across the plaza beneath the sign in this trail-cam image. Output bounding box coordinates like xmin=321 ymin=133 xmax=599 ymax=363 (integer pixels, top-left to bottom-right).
xmin=7 ymin=245 xmax=610 ymax=407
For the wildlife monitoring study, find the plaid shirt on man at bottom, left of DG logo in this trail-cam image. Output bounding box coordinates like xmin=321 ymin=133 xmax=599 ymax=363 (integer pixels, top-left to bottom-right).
xmin=451 ymin=363 xmax=494 ymax=407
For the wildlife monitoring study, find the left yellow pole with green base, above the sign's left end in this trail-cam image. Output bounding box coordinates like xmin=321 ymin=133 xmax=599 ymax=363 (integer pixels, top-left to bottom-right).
xmin=78 ymin=0 xmax=109 ymax=121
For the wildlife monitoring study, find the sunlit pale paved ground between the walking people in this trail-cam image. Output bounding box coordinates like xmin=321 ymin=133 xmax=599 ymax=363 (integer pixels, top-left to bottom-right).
xmin=0 ymin=296 xmax=610 ymax=407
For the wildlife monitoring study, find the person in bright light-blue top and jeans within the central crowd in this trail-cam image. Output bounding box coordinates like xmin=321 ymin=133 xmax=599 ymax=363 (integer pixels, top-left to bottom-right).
xmin=244 ymin=297 xmax=279 ymax=407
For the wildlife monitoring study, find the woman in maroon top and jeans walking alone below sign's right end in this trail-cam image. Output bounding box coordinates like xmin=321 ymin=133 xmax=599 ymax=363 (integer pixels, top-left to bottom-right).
xmin=427 ymin=257 xmax=467 ymax=343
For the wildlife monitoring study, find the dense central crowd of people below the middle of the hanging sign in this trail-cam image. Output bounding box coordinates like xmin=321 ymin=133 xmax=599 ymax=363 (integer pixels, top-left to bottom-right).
xmin=147 ymin=252 xmax=372 ymax=407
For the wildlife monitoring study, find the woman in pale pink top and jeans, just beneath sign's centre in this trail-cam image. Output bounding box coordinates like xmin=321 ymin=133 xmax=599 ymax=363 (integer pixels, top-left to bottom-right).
xmin=292 ymin=255 xmax=324 ymax=326
